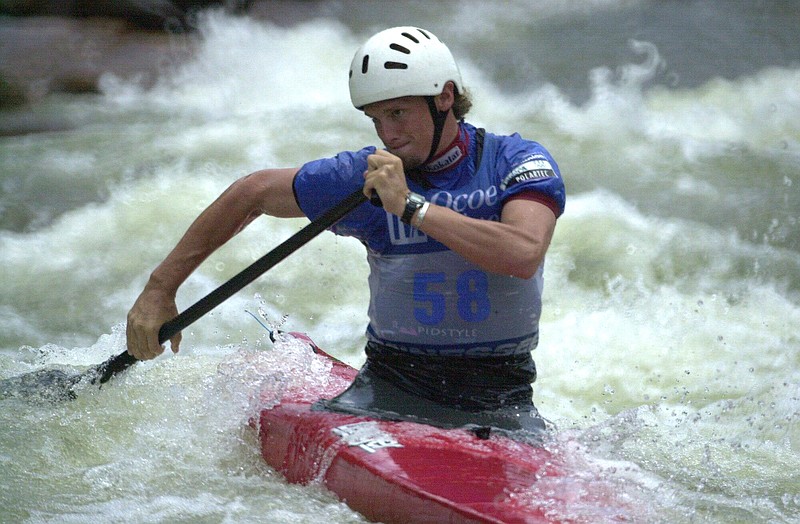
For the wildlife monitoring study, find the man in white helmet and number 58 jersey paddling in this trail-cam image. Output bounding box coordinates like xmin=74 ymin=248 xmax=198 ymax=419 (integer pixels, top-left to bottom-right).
xmin=128 ymin=27 xmax=565 ymax=438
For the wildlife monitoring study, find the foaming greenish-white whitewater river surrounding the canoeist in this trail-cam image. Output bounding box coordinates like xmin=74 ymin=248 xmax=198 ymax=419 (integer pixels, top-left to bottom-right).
xmin=0 ymin=0 xmax=800 ymax=523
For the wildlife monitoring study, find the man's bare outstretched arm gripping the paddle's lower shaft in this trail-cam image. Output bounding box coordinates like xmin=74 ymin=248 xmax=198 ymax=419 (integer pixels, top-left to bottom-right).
xmin=127 ymin=168 xmax=303 ymax=360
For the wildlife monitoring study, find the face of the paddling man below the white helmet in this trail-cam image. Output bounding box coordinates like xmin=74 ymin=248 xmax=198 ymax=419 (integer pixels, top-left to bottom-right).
xmin=364 ymin=96 xmax=433 ymax=169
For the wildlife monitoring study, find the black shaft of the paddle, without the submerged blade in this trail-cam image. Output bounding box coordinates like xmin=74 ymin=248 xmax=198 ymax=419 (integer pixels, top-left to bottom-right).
xmin=91 ymin=189 xmax=366 ymax=384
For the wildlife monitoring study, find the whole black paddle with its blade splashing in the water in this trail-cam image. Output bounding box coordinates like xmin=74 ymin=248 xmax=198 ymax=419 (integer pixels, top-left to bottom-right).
xmin=0 ymin=189 xmax=366 ymax=399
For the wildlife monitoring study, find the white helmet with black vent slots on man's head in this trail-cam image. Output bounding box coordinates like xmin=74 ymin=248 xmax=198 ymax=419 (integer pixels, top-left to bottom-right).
xmin=350 ymin=27 xmax=463 ymax=109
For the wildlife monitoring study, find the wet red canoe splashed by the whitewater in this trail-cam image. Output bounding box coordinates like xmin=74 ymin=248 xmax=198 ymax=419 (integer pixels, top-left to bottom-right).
xmin=257 ymin=334 xmax=631 ymax=523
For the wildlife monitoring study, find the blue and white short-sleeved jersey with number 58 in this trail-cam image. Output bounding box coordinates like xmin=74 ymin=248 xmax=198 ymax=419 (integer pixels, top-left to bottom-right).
xmin=294 ymin=123 xmax=565 ymax=356
